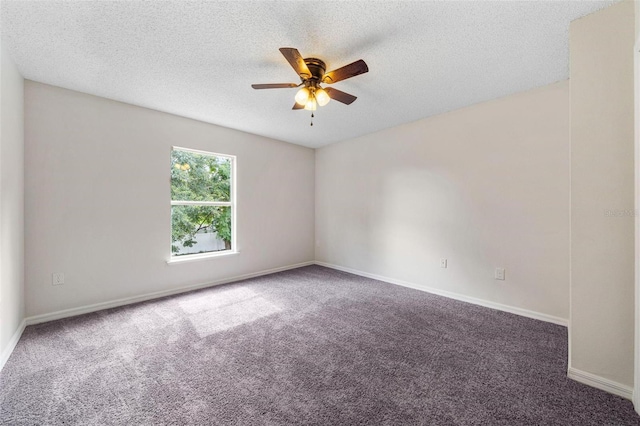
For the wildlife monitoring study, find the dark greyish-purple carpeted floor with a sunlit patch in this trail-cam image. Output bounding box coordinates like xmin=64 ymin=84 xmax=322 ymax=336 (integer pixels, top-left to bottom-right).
xmin=0 ymin=266 xmax=640 ymax=425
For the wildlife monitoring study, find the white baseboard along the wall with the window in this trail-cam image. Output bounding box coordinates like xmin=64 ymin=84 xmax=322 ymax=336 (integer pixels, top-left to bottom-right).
xmin=26 ymin=262 xmax=314 ymax=325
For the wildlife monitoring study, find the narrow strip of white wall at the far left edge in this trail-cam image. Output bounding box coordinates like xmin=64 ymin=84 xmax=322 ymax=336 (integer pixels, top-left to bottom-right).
xmin=0 ymin=43 xmax=24 ymax=362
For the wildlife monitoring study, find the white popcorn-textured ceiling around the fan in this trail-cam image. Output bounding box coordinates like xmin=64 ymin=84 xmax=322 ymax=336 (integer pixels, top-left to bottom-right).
xmin=0 ymin=1 xmax=614 ymax=147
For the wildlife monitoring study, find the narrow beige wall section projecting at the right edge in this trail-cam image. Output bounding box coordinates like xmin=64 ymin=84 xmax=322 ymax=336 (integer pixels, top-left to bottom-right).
xmin=569 ymin=2 xmax=635 ymax=386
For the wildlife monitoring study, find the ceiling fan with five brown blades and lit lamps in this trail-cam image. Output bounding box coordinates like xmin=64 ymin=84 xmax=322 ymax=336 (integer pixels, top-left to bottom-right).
xmin=251 ymin=47 xmax=369 ymax=114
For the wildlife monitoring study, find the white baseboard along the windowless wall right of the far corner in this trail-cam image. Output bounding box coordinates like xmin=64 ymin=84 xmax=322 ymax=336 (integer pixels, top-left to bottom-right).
xmin=315 ymin=261 xmax=569 ymax=327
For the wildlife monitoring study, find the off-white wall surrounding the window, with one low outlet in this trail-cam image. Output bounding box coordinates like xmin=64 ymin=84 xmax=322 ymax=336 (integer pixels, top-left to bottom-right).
xmin=25 ymin=81 xmax=314 ymax=316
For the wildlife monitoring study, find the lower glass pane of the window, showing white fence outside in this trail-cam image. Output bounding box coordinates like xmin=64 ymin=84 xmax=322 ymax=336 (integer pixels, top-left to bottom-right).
xmin=171 ymin=206 xmax=231 ymax=256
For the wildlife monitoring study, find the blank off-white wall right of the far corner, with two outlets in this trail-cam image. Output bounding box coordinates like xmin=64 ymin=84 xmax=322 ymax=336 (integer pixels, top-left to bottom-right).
xmin=316 ymin=81 xmax=569 ymax=319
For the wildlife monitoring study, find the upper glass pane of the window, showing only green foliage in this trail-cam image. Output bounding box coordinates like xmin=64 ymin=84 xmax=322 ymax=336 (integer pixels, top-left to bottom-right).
xmin=171 ymin=149 xmax=231 ymax=201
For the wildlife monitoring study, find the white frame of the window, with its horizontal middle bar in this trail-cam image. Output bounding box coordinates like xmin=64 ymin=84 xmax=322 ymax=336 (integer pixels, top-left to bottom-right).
xmin=167 ymin=146 xmax=238 ymax=263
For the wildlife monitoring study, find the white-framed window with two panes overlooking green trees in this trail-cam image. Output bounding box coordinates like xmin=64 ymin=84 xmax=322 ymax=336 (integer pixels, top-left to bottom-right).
xmin=171 ymin=147 xmax=235 ymax=258
